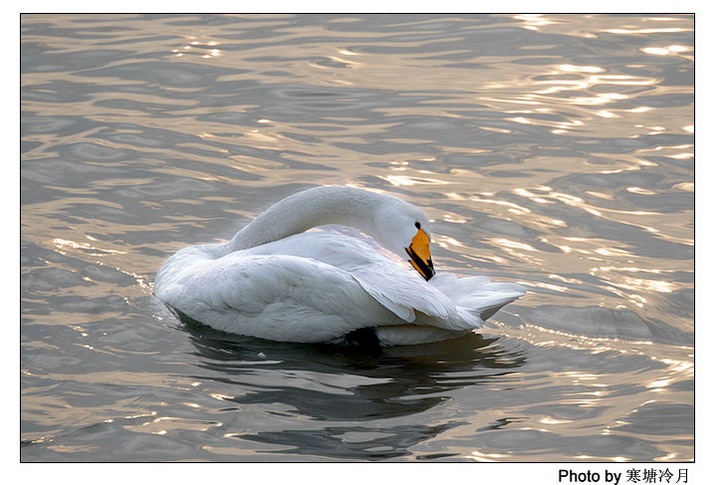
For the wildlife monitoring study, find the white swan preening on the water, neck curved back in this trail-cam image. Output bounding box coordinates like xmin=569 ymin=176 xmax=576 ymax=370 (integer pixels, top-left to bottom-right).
xmin=154 ymin=186 xmax=524 ymax=345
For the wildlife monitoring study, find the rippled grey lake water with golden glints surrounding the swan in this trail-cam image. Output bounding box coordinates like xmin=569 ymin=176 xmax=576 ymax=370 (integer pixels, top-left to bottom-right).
xmin=21 ymin=15 xmax=694 ymax=461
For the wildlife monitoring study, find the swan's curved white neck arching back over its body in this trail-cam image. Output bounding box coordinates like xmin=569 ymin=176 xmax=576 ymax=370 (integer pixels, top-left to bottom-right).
xmin=227 ymin=187 xmax=384 ymax=252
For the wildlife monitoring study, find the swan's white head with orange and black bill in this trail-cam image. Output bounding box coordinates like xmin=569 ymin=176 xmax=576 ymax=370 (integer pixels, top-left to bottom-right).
xmin=376 ymin=199 xmax=435 ymax=281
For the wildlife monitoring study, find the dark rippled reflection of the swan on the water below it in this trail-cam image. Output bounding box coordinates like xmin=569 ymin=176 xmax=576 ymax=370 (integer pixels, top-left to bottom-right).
xmin=183 ymin=319 xmax=525 ymax=460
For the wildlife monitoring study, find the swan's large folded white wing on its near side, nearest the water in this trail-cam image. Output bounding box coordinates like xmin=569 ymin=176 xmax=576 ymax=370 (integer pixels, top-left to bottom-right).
xmin=157 ymin=253 xmax=404 ymax=342
